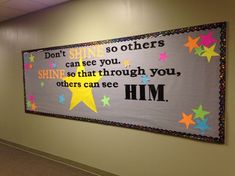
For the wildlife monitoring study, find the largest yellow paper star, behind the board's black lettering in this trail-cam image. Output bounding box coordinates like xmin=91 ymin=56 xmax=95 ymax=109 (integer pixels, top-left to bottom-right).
xmin=62 ymin=59 xmax=102 ymax=112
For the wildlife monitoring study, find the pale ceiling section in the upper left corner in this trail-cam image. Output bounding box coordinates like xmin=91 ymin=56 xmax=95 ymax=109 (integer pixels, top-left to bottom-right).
xmin=0 ymin=0 xmax=69 ymax=22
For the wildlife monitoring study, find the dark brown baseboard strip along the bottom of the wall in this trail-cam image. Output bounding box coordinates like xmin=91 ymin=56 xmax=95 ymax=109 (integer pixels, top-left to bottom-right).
xmin=0 ymin=139 xmax=117 ymax=176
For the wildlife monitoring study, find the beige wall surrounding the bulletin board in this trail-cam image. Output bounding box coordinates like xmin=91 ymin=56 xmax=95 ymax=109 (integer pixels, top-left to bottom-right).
xmin=0 ymin=0 xmax=235 ymax=176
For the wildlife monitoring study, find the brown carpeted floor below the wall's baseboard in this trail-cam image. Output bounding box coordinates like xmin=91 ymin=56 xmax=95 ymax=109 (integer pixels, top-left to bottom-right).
xmin=0 ymin=143 xmax=97 ymax=176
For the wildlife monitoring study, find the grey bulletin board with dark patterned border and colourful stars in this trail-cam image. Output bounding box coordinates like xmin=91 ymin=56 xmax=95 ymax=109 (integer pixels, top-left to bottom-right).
xmin=22 ymin=22 xmax=226 ymax=143
